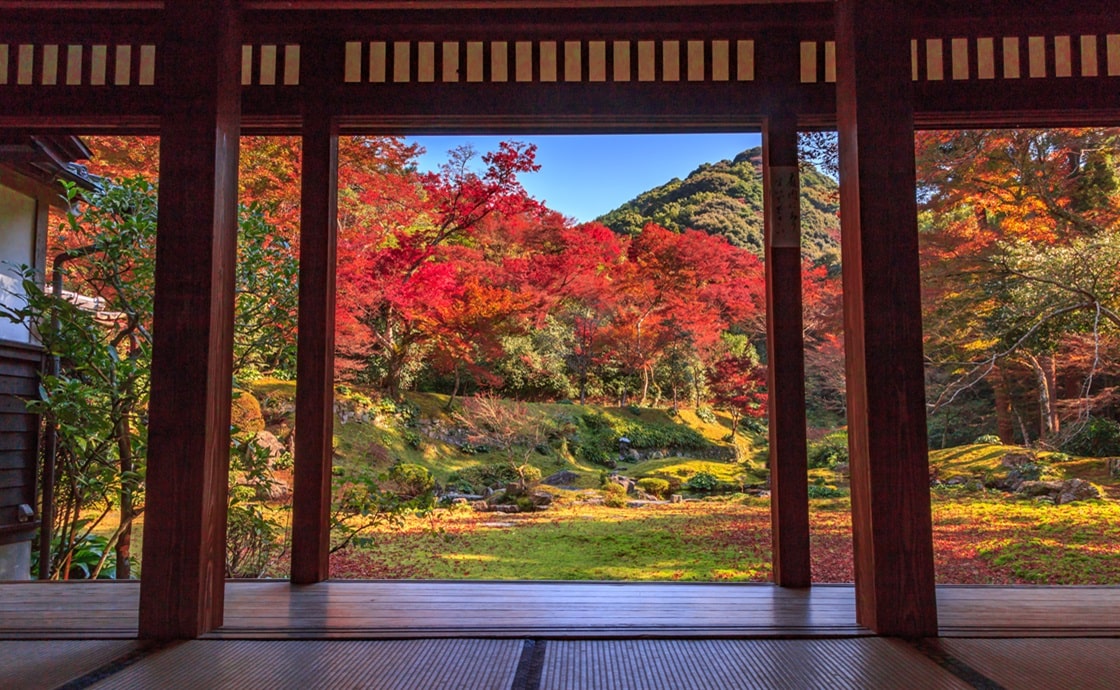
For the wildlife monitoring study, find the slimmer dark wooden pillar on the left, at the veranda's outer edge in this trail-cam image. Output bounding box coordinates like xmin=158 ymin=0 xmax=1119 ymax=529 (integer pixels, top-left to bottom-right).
xmin=291 ymin=46 xmax=342 ymax=585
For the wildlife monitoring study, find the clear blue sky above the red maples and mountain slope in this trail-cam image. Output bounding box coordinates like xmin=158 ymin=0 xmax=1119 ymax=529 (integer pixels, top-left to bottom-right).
xmin=409 ymin=133 xmax=762 ymax=222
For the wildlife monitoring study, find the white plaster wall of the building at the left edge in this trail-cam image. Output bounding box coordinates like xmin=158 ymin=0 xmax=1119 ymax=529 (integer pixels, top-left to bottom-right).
xmin=0 ymin=186 xmax=36 ymax=343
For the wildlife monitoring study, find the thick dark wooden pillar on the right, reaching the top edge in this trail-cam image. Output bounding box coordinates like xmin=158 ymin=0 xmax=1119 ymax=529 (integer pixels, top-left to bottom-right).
xmin=837 ymin=0 xmax=937 ymax=636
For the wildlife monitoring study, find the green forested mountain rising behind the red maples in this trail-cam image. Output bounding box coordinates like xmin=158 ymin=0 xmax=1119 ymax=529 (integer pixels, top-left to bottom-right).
xmin=598 ymin=147 xmax=840 ymax=261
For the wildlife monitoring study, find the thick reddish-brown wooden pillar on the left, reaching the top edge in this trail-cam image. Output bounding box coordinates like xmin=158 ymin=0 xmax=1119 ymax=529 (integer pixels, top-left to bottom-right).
xmin=140 ymin=0 xmax=241 ymax=640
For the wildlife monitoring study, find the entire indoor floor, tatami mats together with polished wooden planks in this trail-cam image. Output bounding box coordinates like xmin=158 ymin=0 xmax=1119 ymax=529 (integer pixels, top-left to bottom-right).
xmin=0 ymin=581 xmax=1120 ymax=690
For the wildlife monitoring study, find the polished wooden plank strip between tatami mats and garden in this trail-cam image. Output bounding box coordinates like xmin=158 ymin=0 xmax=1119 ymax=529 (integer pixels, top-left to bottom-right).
xmin=0 ymin=580 xmax=1120 ymax=640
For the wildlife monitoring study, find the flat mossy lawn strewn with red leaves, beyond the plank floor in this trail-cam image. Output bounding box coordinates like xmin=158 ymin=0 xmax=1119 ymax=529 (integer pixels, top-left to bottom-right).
xmin=332 ymin=496 xmax=1120 ymax=585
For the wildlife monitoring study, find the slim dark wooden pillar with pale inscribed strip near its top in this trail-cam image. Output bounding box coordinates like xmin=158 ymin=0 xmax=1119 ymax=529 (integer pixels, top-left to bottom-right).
xmin=763 ymin=113 xmax=812 ymax=587
